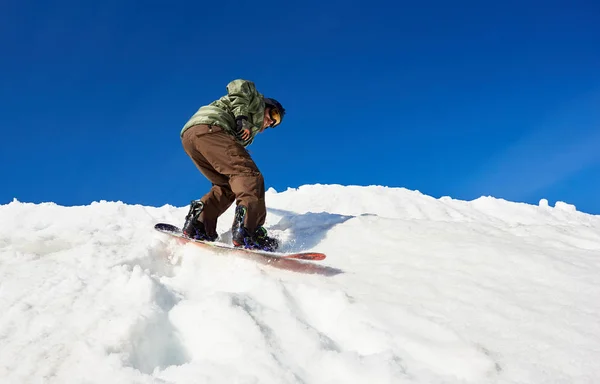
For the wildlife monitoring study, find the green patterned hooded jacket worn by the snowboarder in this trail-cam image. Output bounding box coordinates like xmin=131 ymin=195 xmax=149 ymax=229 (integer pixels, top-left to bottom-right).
xmin=180 ymin=79 xmax=265 ymax=147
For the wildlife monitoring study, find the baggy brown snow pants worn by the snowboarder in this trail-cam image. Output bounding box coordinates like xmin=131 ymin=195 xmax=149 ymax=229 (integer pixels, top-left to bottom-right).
xmin=181 ymin=125 xmax=267 ymax=235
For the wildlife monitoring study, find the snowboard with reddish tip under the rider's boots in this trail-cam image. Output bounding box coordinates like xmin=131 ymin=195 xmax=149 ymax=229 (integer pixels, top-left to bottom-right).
xmin=154 ymin=223 xmax=325 ymax=261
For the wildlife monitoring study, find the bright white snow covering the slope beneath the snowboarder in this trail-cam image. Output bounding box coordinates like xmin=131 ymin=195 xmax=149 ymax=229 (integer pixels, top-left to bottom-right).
xmin=0 ymin=185 xmax=600 ymax=384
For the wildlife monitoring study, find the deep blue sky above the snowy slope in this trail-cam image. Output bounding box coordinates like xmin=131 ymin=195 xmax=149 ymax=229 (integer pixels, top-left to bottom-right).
xmin=0 ymin=0 xmax=600 ymax=214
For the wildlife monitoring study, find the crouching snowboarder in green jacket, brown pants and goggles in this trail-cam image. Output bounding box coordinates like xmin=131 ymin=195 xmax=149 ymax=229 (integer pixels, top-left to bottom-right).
xmin=181 ymin=79 xmax=285 ymax=251
